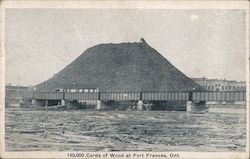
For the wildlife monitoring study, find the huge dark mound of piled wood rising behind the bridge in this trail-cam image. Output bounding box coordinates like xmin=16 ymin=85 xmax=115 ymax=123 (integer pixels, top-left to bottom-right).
xmin=37 ymin=38 xmax=205 ymax=92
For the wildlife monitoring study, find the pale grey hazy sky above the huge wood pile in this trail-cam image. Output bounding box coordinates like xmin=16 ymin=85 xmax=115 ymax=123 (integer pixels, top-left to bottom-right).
xmin=5 ymin=9 xmax=246 ymax=86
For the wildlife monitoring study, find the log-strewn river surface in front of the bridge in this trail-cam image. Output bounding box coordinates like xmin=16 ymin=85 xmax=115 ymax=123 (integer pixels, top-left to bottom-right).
xmin=5 ymin=106 xmax=246 ymax=152
